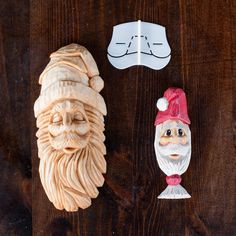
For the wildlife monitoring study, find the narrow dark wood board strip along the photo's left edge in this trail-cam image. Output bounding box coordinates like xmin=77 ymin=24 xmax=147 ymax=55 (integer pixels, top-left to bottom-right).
xmin=0 ymin=0 xmax=32 ymax=236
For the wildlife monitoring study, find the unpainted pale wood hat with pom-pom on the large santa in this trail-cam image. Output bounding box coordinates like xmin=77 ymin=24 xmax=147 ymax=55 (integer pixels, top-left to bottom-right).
xmin=34 ymin=44 xmax=107 ymax=117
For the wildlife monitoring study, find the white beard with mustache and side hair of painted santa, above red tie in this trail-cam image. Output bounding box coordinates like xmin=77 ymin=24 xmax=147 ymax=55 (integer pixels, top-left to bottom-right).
xmin=154 ymin=124 xmax=191 ymax=176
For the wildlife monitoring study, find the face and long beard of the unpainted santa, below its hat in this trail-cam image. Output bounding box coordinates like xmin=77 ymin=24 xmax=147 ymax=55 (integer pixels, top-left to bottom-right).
xmin=36 ymin=99 xmax=106 ymax=211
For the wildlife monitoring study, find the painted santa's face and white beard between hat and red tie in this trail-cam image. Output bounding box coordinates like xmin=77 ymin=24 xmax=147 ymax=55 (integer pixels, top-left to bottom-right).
xmin=155 ymin=120 xmax=191 ymax=175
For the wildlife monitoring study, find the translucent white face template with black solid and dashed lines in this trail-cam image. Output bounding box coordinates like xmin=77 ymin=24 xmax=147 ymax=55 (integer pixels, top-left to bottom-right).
xmin=107 ymin=20 xmax=171 ymax=70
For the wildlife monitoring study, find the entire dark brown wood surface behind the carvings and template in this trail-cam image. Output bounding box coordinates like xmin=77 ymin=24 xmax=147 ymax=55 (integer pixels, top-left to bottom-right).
xmin=0 ymin=0 xmax=236 ymax=236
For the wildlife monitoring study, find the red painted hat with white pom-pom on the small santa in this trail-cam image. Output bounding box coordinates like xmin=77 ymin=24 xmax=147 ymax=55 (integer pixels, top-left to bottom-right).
xmin=155 ymin=88 xmax=190 ymax=125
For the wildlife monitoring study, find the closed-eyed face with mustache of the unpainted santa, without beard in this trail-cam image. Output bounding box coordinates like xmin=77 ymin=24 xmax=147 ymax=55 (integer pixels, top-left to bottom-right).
xmin=48 ymin=100 xmax=90 ymax=153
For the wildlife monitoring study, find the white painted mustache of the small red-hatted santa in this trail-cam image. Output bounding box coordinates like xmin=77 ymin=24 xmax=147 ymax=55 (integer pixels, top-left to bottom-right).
xmin=158 ymin=143 xmax=190 ymax=156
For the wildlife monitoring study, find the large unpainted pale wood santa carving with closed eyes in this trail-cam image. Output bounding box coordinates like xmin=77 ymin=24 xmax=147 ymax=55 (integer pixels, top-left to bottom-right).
xmin=34 ymin=44 xmax=106 ymax=211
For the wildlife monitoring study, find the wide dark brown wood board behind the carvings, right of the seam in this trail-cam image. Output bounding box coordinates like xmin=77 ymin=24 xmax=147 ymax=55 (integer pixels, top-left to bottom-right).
xmin=30 ymin=1 xmax=236 ymax=235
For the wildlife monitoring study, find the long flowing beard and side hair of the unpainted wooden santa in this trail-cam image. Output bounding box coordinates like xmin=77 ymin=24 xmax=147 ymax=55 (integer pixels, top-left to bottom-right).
xmin=36 ymin=106 xmax=106 ymax=211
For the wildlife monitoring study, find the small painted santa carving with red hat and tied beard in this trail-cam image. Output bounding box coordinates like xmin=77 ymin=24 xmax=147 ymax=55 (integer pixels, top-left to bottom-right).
xmin=154 ymin=88 xmax=191 ymax=199
